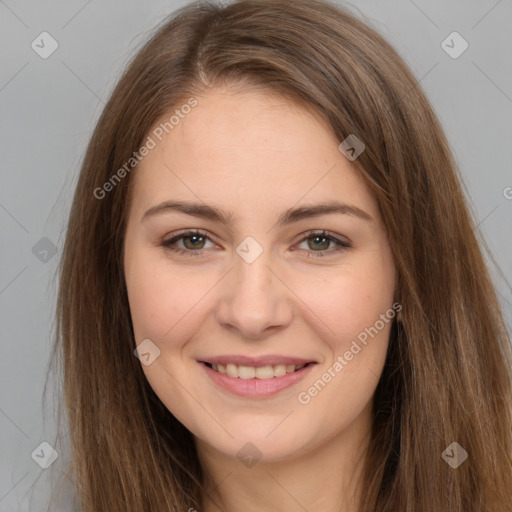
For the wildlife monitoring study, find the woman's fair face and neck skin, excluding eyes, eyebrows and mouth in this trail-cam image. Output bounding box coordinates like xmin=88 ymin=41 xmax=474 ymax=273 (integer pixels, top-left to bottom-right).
xmin=124 ymin=88 xmax=395 ymax=512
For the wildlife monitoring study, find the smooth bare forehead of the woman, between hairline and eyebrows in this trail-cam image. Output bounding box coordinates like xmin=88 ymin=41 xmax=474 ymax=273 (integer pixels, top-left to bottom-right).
xmin=127 ymin=89 xmax=377 ymax=222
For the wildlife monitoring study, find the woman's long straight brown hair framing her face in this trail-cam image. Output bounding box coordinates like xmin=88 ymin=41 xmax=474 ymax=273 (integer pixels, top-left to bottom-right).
xmin=55 ymin=0 xmax=512 ymax=512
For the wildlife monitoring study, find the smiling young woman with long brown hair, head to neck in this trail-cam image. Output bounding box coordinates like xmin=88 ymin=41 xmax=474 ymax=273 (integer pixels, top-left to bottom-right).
xmin=52 ymin=0 xmax=512 ymax=512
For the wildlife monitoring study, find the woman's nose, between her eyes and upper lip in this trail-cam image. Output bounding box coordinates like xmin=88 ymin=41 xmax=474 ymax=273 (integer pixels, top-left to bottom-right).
xmin=216 ymin=247 xmax=293 ymax=340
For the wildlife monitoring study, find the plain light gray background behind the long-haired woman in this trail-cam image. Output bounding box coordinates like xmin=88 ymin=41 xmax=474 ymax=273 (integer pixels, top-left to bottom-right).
xmin=0 ymin=0 xmax=512 ymax=512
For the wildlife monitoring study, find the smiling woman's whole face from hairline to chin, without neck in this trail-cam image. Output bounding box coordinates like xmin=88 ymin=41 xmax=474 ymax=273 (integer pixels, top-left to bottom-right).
xmin=124 ymin=89 xmax=395 ymax=461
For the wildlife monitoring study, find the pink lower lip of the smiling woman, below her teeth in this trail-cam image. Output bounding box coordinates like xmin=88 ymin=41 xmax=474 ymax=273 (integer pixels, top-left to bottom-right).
xmin=199 ymin=363 xmax=315 ymax=398
